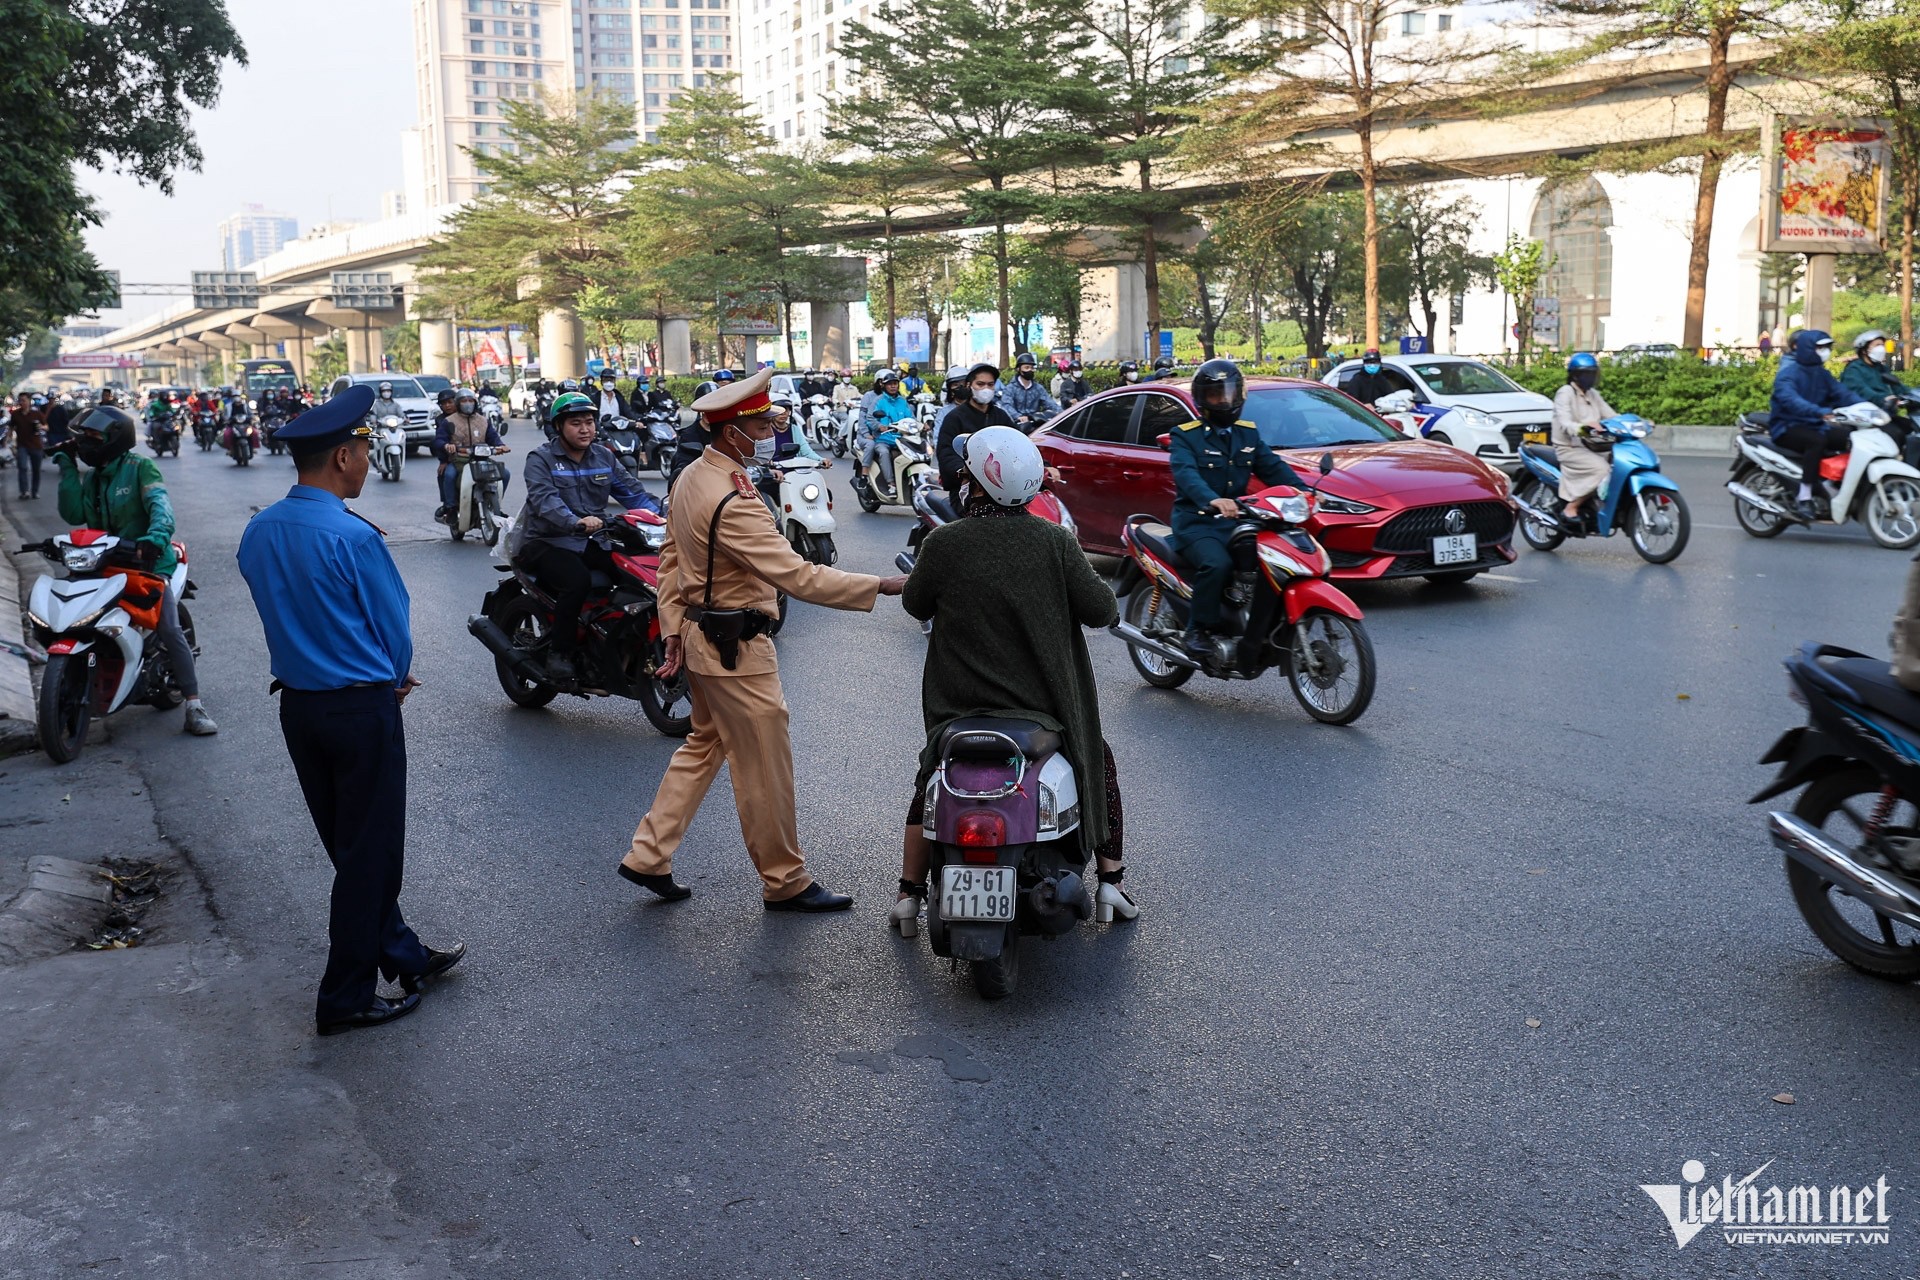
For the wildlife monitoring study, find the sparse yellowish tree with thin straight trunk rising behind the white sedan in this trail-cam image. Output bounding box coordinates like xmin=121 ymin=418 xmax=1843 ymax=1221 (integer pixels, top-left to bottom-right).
xmin=1204 ymin=0 xmax=1505 ymax=347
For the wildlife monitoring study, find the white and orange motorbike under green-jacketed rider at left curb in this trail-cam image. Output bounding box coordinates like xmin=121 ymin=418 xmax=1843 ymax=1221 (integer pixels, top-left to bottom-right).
xmin=21 ymin=530 xmax=200 ymax=764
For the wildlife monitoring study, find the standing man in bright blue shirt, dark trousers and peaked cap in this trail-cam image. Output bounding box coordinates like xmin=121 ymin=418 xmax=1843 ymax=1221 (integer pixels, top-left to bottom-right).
xmin=238 ymin=386 xmax=467 ymax=1036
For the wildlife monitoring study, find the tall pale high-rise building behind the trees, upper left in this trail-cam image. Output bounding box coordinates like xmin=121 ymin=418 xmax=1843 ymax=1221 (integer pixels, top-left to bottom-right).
xmin=407 ymin=0 xmax=739 ymax=207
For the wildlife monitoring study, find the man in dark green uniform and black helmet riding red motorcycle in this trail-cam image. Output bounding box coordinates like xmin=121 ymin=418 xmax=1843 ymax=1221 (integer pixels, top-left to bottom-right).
xmin=1167 ymin=361 xmax=1306 ymax=654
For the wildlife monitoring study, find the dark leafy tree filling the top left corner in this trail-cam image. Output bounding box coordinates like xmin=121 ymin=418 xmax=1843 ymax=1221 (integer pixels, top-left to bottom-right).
xmin=0 ymin=0 xmax=246 ymax=347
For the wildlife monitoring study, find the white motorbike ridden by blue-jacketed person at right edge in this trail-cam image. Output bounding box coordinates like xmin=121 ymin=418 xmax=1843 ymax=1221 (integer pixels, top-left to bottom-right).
xmin=1726 ymin=403 xmax=1920 ymax=551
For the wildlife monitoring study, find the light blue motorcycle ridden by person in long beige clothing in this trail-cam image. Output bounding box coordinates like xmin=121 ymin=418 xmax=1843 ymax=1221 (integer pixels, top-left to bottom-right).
xmin=1513 ymin=413 xmax=1693 ymax=564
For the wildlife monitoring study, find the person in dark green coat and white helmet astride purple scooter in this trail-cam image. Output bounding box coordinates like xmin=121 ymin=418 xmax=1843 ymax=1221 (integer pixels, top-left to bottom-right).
xmin=889 ymin=426 xmax=1140 ymax=936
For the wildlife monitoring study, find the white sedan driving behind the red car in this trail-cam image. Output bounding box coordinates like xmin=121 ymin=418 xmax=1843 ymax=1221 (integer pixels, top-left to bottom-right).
xmin=1327 ymin=355 xmax=1553 ymax=472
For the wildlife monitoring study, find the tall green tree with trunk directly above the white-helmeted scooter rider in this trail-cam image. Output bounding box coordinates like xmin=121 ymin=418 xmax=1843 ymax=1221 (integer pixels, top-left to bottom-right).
xmin=829 ymin=0 xmax=1085 ymax=365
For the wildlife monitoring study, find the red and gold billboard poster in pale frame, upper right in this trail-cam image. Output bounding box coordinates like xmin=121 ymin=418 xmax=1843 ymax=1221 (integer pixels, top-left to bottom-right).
xmin=1761 ymin=117 xmax=1893 ymax=253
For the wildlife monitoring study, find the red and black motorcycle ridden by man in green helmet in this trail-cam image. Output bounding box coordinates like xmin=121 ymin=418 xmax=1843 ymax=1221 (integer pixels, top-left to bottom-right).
xmin=467 ymin=510 xmax=693 ymax=737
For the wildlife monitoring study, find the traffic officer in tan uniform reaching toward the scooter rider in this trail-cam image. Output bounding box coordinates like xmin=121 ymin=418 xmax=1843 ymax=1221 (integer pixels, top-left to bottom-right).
xmin=618 ymin=368 xmax=906 ymax=912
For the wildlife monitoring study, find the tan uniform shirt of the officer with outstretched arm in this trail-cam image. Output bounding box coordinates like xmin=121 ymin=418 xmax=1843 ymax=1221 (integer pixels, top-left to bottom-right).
xmin=660 ymin=449 xmax=879 ymax=676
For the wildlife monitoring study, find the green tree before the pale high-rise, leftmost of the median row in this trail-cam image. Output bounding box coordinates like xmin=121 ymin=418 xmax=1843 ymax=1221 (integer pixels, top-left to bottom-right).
xmin=420 ymin=92 xmax=636 ymax=339
